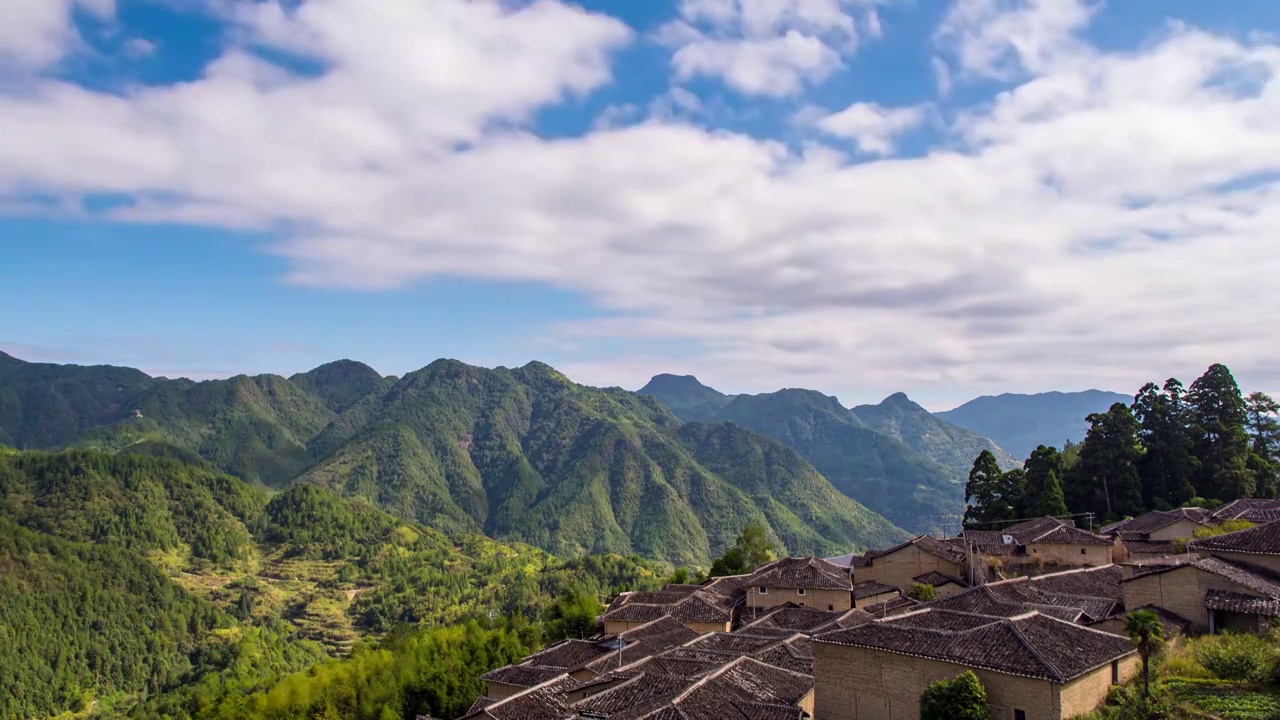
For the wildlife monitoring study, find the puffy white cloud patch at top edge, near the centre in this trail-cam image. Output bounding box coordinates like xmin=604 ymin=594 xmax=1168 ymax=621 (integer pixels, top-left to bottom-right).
xmin=658 ymin=0 xmax=881 ymax=96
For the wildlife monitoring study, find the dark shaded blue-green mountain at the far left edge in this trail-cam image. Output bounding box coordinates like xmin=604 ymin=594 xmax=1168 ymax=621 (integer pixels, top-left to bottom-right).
xmin=0 ymin=352 xmax=156 ymax=448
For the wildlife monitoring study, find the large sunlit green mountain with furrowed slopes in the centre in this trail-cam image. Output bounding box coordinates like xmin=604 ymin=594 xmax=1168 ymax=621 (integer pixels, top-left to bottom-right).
xmin=302 ymin=360 xmax=901 ymax=565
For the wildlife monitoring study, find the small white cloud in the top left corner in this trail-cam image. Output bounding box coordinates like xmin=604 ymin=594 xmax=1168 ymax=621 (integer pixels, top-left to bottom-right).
xmin=0 ymin=0 xmax=115 ymax=69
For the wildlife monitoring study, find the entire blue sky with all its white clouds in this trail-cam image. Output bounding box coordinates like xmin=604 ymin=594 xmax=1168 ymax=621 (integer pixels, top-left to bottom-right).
xmin=0 ymin=0 xmax=1280 ymax=409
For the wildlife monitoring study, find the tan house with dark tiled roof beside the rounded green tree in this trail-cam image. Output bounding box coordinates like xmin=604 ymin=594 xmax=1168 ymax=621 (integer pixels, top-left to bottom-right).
xmin=745 ymin=557 xmax=854 ymax=616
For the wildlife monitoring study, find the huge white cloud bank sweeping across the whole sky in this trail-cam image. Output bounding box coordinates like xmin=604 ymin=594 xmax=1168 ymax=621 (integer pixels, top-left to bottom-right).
xmin=0 ymin=0 xmax=1280 ymax=389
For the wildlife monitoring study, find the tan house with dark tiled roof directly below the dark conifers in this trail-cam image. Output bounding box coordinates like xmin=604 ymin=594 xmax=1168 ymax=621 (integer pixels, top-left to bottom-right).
xmin=963 ymin=518 xmax=1114 ymax=577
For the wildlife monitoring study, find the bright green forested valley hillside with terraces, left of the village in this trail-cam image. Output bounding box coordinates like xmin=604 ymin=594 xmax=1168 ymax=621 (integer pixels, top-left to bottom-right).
xmin=0 ymin=451 xmax=671 ymax=719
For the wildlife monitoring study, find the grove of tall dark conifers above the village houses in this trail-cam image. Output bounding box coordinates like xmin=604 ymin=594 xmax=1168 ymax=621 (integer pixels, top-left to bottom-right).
xmin=964 ymin=365 xmax=1280 ymax=528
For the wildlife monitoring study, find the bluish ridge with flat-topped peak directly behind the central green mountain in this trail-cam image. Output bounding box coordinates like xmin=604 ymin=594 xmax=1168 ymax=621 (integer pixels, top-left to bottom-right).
xmin=641 ymin=375 xmax=977 ymax=533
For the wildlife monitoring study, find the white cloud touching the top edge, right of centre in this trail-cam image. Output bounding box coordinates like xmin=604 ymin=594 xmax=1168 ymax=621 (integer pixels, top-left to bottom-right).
xmin=937 ymin=0 xmax=1101 ymax=79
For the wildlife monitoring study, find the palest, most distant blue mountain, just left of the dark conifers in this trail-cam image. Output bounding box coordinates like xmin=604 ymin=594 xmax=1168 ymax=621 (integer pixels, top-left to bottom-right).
xmin=934 ymin=389 xmax=1133 ymax=457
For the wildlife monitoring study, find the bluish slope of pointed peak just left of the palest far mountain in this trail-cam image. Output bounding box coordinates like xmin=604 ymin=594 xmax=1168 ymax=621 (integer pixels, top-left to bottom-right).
xmin=852 ymin=392 xmax=1021 ymax=478
